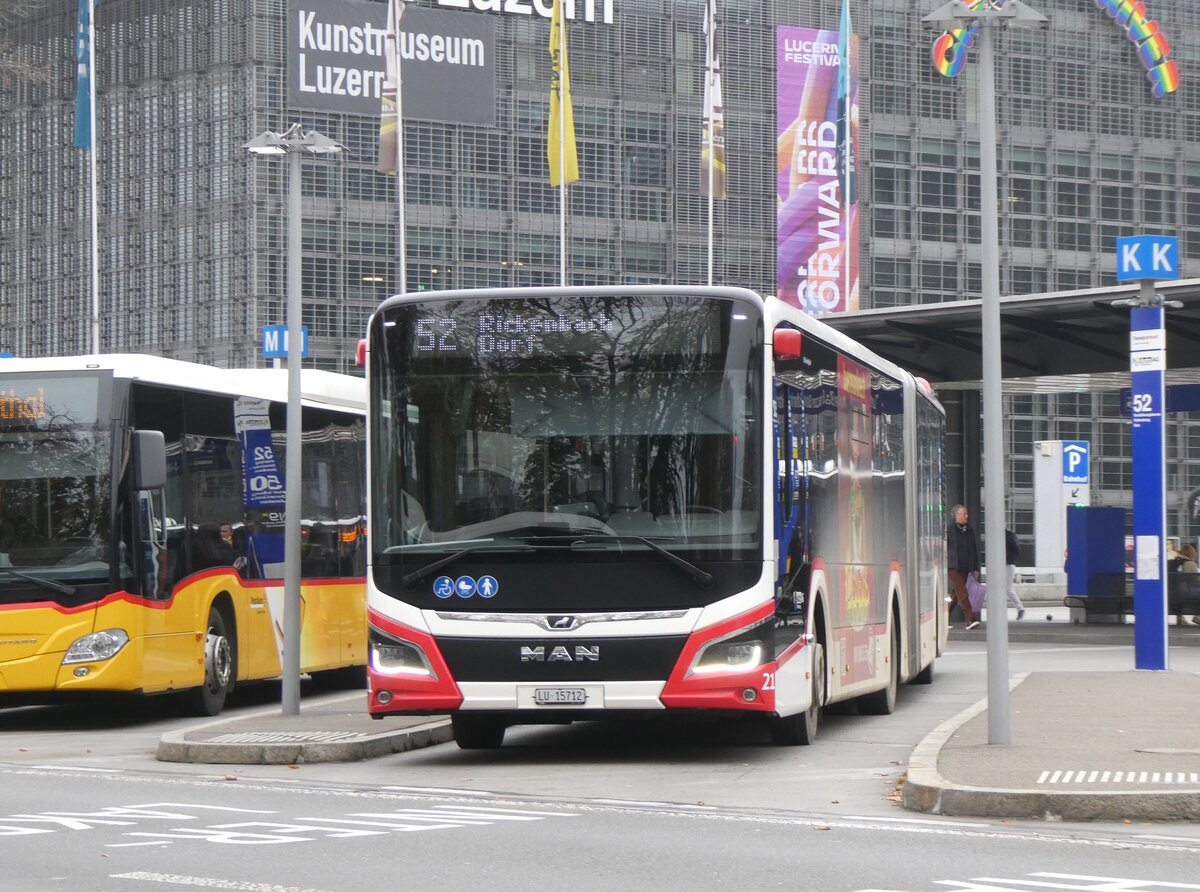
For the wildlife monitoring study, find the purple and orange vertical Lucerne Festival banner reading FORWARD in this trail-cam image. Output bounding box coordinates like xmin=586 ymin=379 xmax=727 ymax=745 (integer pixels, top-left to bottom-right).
xmin=775 ymin=25 xmax=859 ymax=315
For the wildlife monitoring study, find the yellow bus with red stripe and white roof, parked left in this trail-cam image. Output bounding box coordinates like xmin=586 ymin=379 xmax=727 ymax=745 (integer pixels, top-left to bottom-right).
xmin=0 ymin=355 xmax=366 ymax=716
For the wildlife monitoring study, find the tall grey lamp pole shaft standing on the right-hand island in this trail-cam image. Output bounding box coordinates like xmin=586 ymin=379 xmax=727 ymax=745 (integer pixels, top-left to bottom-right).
xmin=979 ymin=19 xmax=1012 ymax=744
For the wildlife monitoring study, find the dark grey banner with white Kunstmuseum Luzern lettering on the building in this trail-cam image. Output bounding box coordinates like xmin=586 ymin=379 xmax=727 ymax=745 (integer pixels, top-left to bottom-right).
xmin=287 ymin=0 xmax=496 ymax=126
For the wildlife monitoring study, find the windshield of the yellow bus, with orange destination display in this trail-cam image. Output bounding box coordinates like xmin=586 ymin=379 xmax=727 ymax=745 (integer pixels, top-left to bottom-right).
xmin=0 ymin=377 xmax=112 ymax=588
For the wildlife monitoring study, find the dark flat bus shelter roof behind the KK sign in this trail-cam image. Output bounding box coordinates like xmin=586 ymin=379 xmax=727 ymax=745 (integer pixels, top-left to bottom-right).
xmin=821 ymin=279 xmax=1200 ymax=393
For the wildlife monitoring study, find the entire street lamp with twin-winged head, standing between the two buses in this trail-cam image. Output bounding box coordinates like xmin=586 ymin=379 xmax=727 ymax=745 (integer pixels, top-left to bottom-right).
xmin=242 ymin=124 xmax=346 ymax=716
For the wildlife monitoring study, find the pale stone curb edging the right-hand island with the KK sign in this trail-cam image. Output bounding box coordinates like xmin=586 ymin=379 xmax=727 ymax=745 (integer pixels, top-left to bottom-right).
xmin=901 ymin=672 xmax=1200 ymax=821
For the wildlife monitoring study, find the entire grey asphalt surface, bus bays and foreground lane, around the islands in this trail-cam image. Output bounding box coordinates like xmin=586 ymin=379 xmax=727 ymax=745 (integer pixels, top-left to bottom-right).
xmin=7 ymin=642 xmax=1200 ymax=892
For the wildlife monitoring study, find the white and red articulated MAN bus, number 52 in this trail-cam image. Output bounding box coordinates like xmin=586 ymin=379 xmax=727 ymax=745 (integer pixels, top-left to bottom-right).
xmin=366 ymin=286 xmax=947 ymax=748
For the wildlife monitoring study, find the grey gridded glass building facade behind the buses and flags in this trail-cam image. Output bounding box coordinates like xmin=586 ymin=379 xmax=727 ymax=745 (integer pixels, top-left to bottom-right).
xmin=0 ymin=0 xmax=1200 ymax=547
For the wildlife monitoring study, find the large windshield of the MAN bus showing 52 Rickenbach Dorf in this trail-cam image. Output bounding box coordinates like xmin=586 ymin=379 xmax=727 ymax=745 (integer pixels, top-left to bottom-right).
xmin=371 ymin=294 xmax=763 ymax=568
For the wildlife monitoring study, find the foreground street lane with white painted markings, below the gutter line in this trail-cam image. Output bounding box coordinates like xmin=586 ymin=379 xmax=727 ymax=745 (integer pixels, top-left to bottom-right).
xmin=0 ymin=767 xmax=1200 ymax=892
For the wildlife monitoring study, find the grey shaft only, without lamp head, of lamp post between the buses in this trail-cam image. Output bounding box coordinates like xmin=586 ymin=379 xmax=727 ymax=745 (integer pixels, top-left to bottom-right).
xmin=283 ymin=143 xmax=304 ymax=716
